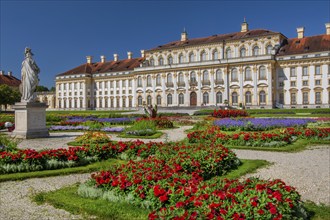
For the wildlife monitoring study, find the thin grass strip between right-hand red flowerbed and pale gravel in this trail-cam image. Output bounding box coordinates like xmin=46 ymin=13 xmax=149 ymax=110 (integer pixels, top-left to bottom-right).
xmin=224 ymin=139 xmax=330 ymax=152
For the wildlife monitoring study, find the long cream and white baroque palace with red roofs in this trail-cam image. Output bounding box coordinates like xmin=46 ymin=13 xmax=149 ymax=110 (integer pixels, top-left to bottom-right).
xmin=55 ymin=21 xmax=330 ymax=109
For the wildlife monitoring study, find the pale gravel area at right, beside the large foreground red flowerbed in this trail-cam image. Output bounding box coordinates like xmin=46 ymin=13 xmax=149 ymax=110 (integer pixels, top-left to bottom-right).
xmin=234 ymin=145 xmax=330 ymax=205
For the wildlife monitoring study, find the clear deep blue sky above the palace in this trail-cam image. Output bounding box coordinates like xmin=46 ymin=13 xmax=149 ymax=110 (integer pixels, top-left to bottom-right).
xmin=0 ymin=0 xmax=330 ymax=88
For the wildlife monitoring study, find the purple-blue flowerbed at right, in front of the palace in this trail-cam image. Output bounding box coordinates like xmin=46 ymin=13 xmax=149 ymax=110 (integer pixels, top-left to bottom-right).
xmin=214 ymin=118 xmax=316 ymax=131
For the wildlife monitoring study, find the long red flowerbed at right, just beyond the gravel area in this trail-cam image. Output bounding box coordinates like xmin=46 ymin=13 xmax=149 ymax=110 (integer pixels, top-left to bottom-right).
xmin=187 ymin=126 xmax=330 ymax=147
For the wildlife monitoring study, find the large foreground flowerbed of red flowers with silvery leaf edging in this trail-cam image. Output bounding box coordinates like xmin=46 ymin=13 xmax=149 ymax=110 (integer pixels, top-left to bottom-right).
xmin=78 ymin=144 xmax=303 ymax=219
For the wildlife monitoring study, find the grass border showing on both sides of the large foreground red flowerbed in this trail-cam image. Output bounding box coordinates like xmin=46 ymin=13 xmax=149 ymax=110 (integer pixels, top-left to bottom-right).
xmin=33 ymin=160 xmax=270 ymax=219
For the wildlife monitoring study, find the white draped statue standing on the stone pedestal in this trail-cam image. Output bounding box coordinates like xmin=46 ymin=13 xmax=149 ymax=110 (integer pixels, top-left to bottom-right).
xmin=20 ymin=47 xmax=40 ymax=102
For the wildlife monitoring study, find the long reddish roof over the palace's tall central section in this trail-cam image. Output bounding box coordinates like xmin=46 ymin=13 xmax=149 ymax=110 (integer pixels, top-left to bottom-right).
xmin=148 ymin=29 xmax=280 ymax=51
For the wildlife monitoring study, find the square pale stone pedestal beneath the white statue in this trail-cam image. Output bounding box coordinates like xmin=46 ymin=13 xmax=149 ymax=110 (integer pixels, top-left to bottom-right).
xmin=12 ymin=102 xmax=49 ymax=139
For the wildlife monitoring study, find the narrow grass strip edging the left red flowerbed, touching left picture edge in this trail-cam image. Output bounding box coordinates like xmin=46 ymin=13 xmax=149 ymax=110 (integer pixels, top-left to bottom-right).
xmin=0 ymin=159 xmax=125 ymax=182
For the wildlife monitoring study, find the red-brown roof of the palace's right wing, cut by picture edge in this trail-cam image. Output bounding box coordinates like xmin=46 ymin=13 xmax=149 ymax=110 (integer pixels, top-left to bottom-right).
xmin=278 ymin=34 xmax=330 ymax=56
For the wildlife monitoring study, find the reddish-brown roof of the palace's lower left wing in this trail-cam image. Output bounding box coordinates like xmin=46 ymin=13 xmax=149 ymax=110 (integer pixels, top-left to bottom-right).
xmin=57 ymin=58 xmax=144 ymax=76
